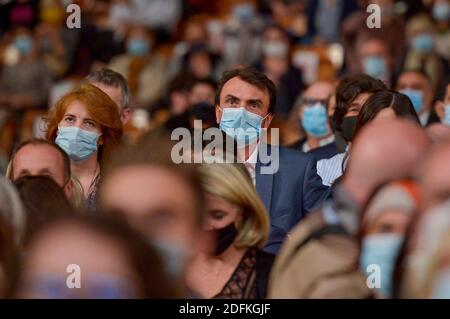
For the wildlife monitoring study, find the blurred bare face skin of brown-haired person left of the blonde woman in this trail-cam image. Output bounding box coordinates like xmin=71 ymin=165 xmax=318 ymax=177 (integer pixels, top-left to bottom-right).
xmin=100 ymin=166 xmax=198 ymax=249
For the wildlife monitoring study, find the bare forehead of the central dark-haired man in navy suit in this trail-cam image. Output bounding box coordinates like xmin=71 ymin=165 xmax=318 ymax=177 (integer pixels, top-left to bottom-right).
xmin=220 ymin=76 xmax=269 ymax=104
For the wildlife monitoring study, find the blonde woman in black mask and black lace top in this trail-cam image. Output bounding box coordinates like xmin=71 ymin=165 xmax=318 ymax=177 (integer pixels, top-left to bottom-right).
xmin=186 ymin=163 xmax=274 ymax=299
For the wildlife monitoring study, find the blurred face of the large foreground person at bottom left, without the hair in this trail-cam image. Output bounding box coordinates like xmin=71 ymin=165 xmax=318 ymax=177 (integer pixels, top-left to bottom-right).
xmin=17 ymin=223 xmax=139 ymax=298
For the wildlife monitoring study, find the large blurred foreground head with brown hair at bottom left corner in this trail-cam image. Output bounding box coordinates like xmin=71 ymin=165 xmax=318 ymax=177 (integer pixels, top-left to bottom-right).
xmin=16 ymin=215 xmax=176 ymax=299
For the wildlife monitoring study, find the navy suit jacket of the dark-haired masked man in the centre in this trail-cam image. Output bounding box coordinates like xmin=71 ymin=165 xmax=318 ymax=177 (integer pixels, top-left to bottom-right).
xmin=255 ymin=145 xmax=330 ymax=253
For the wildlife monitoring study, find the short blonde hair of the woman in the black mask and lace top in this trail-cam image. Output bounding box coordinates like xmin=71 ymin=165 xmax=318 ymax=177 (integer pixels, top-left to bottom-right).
xmin=199 ymin=163 xmax=270 ymax=248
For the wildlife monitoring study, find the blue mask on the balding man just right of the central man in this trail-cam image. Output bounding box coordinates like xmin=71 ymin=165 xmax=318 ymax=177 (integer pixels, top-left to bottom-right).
xmin=301 ymin=103 xmax=330 ymax=137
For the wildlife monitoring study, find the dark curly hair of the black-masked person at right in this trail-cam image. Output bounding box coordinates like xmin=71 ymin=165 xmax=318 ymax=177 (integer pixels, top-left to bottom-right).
xmin=333 ymin=74 xmax=387 ymax=131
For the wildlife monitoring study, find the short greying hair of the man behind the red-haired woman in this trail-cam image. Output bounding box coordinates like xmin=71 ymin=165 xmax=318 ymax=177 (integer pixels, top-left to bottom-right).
xmin=86 ymin=68 xmax=131 ymax=109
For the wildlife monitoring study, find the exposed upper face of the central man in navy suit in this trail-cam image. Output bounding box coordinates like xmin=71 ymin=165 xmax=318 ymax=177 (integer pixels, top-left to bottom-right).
xmin=216 ymin=77 xmax=273 ymax=128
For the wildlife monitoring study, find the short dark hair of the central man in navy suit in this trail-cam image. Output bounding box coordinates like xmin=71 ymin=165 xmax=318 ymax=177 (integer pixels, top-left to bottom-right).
xmin=215 ymin=67 xmax=277 ymax=114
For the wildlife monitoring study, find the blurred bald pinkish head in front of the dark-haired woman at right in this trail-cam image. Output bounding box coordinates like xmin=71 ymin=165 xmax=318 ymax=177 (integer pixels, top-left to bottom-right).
xmin=342 ymin=119 xmax=428 ymax=231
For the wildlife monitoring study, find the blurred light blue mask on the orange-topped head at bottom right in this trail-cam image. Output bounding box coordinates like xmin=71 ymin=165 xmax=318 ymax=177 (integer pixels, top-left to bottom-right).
xmin=359 ymin=234 xmax=404 ymax=298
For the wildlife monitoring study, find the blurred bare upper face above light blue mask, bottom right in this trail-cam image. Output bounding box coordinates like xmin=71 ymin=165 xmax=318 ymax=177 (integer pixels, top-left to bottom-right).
xmin=366 ymin=209 xmax=412 ymax=235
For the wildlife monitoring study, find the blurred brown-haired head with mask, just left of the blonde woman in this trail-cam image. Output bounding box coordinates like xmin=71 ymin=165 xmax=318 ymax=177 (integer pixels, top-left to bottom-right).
xmin=100 ymin=133 xmax=203 ymax=288
